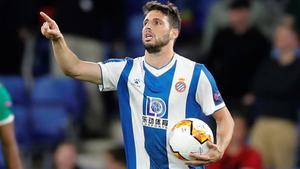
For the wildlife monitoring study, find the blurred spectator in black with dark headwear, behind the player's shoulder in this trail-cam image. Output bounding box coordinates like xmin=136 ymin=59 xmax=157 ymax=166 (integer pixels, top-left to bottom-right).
xmin=206 ymin=0 xmax=270 ymax=112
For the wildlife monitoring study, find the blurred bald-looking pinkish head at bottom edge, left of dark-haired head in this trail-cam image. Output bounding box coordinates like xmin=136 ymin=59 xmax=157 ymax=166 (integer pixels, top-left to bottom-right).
xmin=54 ymin=143 xmax=80 ymax=169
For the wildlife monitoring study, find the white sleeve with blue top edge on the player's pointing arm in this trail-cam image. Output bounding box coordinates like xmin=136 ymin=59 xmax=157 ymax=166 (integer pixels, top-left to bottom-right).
xmin=98 ymin=59 xmax=127 ymax=91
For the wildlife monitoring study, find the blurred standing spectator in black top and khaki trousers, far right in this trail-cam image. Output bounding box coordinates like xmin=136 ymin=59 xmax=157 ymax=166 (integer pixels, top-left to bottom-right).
xmin=251 ymin=22 xmax=300 ymax=169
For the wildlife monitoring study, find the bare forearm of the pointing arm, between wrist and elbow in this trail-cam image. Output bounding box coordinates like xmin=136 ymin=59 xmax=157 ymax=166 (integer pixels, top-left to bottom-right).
xmin=51 ymin=36 xmax=80 ymax=77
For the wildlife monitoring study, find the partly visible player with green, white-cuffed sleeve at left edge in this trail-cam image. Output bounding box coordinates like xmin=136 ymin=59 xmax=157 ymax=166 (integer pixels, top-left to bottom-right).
xmin=0 ymin=84 xmax=22 ymax=169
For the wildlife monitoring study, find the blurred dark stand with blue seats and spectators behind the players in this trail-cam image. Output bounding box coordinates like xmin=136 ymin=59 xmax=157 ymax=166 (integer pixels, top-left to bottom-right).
xmin=0 ymin=0 xmax=300 ymax=169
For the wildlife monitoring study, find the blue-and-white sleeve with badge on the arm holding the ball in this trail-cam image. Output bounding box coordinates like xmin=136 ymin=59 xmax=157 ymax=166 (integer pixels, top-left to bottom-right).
xmin=196 ymin=64 xmax=225 ymax=115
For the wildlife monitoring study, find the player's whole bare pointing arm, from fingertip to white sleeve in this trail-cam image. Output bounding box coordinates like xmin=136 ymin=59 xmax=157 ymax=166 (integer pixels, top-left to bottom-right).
xmin=40 ymin=12 xmax=102 ymax=84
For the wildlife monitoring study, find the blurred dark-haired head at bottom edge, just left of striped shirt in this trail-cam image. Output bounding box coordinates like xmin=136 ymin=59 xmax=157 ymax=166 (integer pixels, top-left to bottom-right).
xmin=104 ymin=146 xmax=126 ymax=169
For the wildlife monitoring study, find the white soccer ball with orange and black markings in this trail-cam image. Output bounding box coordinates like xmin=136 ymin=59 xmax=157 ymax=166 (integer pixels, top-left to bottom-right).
xmin=169 ymin=118 xmax=214 ymax=160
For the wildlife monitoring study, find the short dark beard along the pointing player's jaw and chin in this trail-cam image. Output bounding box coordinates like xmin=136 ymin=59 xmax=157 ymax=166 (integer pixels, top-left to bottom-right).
xmin=144 ymin=34 xmax=170 ymax=53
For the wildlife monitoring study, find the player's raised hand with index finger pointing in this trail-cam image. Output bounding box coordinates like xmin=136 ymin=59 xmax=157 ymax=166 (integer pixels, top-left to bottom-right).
xmin=40 ymin=12 xmax=63 ymax=41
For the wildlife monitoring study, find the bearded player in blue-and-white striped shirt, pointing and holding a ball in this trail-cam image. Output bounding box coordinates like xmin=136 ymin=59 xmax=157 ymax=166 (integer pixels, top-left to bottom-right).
xmin=40 ymin=1 xmax=234 ymax=169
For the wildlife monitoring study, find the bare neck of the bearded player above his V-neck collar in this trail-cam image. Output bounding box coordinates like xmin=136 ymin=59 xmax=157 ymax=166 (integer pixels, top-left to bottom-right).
xmin=145 ymin=43 xmax=174 ymax=69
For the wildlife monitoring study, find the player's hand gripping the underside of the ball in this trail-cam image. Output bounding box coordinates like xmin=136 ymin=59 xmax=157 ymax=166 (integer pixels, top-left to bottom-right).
xmin=185 ymin=141 xmax=223 ymax=166
